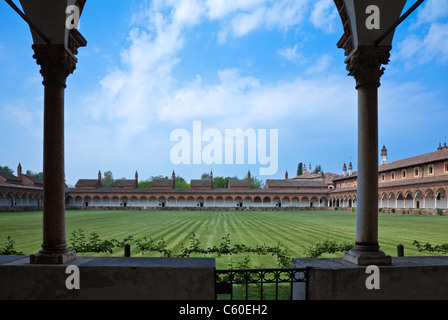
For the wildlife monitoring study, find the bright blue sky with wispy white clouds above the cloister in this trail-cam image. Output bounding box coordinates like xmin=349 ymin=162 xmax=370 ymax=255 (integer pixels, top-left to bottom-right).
xmin=0 ymin=0 xmax=448 ymax=185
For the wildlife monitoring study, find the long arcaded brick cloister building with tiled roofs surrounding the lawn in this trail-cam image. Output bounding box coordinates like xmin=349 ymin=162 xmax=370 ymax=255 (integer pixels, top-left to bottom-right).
xmin=0 ymin=143 xmax=448 ymax=210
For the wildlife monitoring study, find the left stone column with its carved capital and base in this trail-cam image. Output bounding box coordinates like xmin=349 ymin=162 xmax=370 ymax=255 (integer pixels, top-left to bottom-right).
xmin=30 ymin=45 xmax=77 ymax=264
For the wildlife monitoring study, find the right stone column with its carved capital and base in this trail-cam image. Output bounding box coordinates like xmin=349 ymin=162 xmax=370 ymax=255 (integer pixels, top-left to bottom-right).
xmin=344 ymin=46 xmax=391 ymax=265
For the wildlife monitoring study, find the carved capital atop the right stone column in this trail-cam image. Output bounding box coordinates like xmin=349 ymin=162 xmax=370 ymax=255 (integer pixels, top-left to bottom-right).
xmin=345 ymin=47 xmax=391 ymax=89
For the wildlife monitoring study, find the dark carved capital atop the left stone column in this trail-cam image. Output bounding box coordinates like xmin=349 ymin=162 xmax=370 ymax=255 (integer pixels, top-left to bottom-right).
xmin=33 ymin=45 xmax=78 ymax=87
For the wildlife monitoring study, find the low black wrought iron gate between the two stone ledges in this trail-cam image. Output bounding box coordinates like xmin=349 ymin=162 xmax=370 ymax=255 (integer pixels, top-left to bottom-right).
xmin=215 ymin=268 xmax=308 ymax=300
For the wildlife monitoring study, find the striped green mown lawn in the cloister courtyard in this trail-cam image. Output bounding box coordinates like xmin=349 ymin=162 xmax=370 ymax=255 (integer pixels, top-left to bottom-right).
xmin=0 ymin=210 xmax=448 ymax=268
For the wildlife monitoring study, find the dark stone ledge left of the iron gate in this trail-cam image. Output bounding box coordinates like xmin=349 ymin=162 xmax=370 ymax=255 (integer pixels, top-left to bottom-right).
xmin=0 ymin=256 xmax=215 ymax=300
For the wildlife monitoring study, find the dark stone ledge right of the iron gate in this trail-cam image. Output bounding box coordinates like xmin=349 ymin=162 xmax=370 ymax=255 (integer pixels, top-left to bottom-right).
xmin=293 ymin=256 xmax=448 ymax=300
